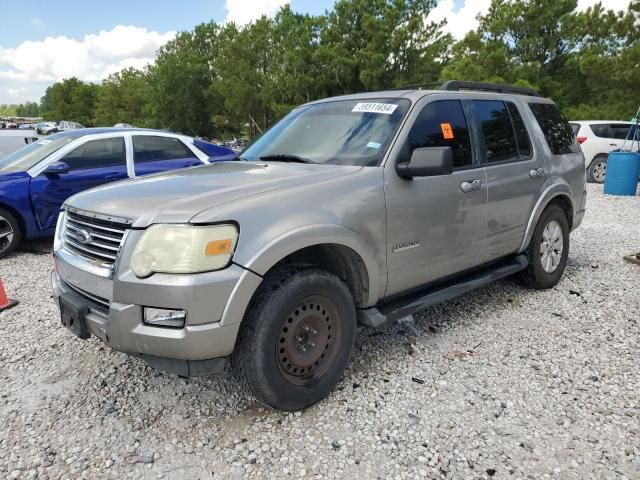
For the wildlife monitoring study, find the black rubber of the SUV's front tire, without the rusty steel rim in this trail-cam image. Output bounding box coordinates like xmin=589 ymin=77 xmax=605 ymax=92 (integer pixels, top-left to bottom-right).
xmin=243 ymin=269 xmax=357 ymax=411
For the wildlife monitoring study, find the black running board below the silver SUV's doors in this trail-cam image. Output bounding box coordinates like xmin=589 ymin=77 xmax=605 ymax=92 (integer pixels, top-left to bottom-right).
xmin=358 ymin=255 xmax=528 ymax=327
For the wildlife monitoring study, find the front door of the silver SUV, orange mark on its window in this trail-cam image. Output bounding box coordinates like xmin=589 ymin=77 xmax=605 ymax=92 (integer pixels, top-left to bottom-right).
xmin=385 ymin=100 xmax=487 ymax=296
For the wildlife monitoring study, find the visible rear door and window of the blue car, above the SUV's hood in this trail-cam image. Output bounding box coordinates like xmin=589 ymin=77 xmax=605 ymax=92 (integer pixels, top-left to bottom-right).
xmin=132 ymin=135 xmax=204 ymax=176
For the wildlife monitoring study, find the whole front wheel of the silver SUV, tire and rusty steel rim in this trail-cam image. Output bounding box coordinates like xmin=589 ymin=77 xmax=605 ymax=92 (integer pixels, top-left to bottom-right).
xmin=231 ymin=269 xmax=356 ymax=411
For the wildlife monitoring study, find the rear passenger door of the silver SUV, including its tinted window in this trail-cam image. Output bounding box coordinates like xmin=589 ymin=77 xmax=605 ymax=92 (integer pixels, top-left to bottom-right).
xmin=472 ymin=100 xmax=548 ymax=261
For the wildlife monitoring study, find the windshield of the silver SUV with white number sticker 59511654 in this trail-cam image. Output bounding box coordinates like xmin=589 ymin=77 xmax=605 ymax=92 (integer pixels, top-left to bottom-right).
xmin=242 ymin=98 xmax=410 ymax=166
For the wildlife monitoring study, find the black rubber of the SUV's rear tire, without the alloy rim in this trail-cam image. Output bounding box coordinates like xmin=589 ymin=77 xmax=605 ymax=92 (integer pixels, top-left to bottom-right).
xmin=529 ymin=205 xmax=569 ymax=288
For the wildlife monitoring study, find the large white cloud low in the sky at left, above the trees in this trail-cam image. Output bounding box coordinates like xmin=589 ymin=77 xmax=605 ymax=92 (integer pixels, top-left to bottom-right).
xmin=0 ymin=25 xmax=175 ymax=103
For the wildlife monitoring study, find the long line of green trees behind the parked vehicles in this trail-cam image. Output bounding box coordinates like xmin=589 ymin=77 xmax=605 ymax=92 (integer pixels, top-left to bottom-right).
xmin=6 ymin=0 xmax=640 ymax=138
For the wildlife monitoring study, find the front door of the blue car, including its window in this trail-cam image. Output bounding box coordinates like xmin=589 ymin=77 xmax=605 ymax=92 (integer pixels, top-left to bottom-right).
xmin=30 ymin=136 xmax=128 ymax=230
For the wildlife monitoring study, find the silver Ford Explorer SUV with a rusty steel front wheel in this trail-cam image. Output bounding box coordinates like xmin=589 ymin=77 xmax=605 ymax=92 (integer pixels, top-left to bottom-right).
xmin=52 ymin=82 xmax=586 ymax=410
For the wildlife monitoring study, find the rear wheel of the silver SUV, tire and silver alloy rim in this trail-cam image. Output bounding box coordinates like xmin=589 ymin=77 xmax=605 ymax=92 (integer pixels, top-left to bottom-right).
xmin=520 ymin=205 xmax=569 ymax=289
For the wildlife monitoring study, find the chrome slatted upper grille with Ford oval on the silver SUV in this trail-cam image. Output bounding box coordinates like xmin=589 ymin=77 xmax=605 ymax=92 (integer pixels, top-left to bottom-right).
xmin=64 ymin=211 xmax=129 ymax=266
